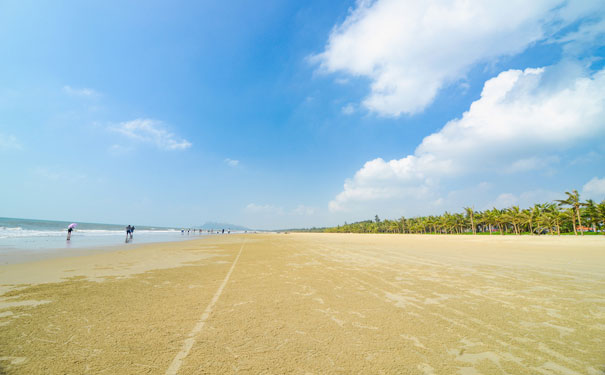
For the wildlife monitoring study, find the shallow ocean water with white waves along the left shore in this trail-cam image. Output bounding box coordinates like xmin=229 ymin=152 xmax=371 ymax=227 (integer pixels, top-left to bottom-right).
xmin=0 ymin=217 xmax=207 ymax=258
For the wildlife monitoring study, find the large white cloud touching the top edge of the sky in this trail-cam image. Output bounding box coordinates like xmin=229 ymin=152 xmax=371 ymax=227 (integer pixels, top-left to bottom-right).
xmin=312 ymin=0 xmax=605 ymax=116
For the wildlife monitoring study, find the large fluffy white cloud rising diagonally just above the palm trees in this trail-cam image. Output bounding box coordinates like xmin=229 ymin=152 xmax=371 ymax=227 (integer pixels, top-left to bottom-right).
xmin=329 ymin=65 xmax=605 ymax=212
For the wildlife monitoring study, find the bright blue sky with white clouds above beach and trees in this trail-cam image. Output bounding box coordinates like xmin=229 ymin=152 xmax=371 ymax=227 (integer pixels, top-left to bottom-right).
xmin=0 ymin=0 xmax=605 ymax=229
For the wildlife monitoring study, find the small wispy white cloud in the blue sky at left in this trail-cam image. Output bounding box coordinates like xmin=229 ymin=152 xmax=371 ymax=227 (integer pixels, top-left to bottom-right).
xmin=112 ymin=119 xmax=191 ymax=151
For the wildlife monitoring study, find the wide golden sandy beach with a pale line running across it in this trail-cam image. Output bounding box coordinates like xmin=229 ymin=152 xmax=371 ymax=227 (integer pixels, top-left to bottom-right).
xmin=0 ymin=234 xmax=605 ymax=375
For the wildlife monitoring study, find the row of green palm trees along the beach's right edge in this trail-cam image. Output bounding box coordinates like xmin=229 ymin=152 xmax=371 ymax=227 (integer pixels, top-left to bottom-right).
xmin=310 ymin=190 xmax=605 ymax=235
